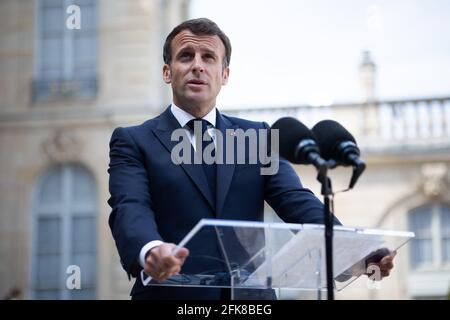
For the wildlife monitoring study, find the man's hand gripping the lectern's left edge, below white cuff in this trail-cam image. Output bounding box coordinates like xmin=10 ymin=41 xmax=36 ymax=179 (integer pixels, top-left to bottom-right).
xmin=144 ymin=243 xmax=189 ymax=281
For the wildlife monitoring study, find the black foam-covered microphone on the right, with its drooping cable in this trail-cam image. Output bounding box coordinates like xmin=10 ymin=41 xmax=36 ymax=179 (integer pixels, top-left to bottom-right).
xmin=312 ymin=120 xmax=366 ymax=189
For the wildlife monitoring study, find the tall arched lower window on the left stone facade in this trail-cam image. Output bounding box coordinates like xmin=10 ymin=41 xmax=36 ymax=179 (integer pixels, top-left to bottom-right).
xmin=32 ymin=165 xmax=97 ymax=299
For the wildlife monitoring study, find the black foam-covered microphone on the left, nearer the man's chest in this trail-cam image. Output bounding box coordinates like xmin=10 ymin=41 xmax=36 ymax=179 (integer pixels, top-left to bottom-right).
xmin=271 ymin=117 xmax=327 ymax=172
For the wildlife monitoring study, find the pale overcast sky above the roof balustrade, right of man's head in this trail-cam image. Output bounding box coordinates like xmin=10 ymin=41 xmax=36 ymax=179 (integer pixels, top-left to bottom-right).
xmin=190 ymin=0 xmax=450 ymax=107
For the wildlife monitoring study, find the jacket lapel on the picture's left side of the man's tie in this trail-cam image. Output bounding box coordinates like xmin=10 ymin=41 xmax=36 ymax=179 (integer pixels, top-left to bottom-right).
xmin=153 ymin=106 xmax=214 ymax=211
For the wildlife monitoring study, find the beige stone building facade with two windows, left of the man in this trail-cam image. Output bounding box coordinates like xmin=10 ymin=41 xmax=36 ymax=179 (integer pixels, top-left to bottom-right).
xmin=0 ymin=0 xmax=188 ymax=299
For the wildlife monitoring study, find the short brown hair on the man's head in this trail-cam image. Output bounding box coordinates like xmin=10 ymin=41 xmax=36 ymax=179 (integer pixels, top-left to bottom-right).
xmin=163 ymin=18 xmax=231 ymax=68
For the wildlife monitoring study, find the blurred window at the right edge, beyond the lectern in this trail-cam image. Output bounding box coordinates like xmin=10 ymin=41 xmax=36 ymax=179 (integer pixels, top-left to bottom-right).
xmin=409 ymin=204 xmax=450 ymax=269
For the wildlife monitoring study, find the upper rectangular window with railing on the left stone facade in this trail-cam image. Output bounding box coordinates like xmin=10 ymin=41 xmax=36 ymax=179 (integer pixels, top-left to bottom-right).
xmin=33 ymin=0 xmax=97 ymax=101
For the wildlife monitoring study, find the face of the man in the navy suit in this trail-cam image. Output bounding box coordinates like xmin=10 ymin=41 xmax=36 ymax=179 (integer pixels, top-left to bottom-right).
xmin=163 ymin=29 xmax=229 ymax=116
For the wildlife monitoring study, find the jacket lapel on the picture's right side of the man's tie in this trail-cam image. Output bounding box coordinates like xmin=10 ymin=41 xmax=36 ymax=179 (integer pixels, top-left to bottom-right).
xmin=216 ymin=110 xmax=238 ymax=217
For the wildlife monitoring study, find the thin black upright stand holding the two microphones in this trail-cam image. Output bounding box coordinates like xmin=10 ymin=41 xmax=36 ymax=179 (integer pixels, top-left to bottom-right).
xmin=317 ymin=163 xmax=335 ymax=300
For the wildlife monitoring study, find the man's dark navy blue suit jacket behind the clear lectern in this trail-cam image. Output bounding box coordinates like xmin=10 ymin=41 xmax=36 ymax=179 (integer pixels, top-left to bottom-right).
xmin=108 ymin=108 xmax=334 ymax=299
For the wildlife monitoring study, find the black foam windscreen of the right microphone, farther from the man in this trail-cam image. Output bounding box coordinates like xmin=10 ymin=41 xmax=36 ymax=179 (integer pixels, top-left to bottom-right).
xmin=311 ymin=120 xmax=356 ymax=160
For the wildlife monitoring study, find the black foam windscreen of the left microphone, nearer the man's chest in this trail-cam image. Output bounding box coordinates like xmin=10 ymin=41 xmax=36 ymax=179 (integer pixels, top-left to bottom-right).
xmin=271 ymin=117 xmax=316 ymax=164
